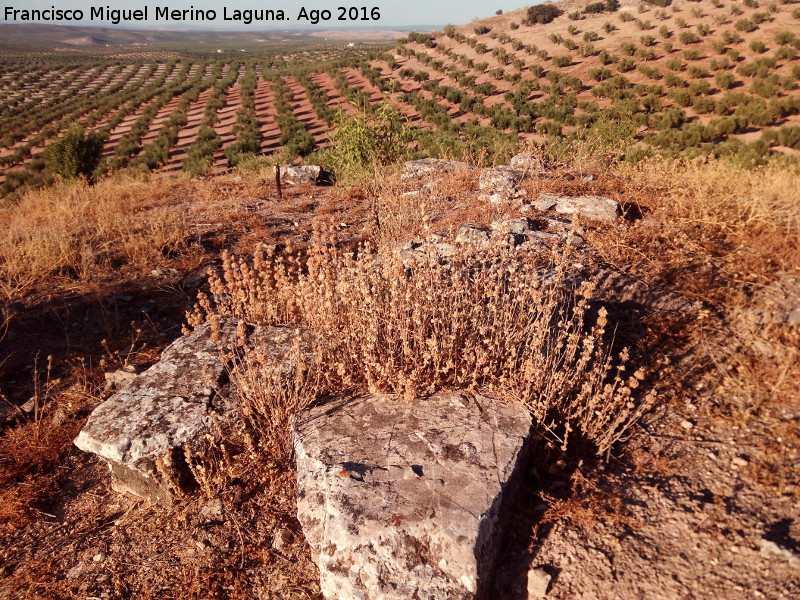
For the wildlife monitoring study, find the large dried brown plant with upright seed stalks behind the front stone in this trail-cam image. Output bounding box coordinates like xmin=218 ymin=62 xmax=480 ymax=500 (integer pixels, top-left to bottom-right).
xmin=190 ymin=228 xmax=650 ymax=452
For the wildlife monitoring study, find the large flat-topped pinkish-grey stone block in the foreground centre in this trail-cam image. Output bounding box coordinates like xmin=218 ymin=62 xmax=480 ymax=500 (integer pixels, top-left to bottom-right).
xmin=295 ymin=393 xmax=531 ymax=600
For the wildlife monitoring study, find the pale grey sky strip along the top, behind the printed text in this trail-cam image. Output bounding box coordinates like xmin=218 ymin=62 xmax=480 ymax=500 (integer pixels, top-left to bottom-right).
xmin=0 ymin=0 xmax=539 ymax=30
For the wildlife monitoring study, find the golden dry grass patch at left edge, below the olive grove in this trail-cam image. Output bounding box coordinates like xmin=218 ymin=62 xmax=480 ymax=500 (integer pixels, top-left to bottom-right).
xmin=0 ymin=182 xmax=188 ymax=300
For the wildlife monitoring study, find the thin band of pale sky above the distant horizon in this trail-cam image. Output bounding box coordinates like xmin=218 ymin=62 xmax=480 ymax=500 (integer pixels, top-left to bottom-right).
xmin=0 ymin=0 xmax=542 ymax=31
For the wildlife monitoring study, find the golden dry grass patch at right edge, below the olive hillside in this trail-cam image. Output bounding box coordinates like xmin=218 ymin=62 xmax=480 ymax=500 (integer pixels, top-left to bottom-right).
xmin=593 ymin=160 xmax=800 ymax=307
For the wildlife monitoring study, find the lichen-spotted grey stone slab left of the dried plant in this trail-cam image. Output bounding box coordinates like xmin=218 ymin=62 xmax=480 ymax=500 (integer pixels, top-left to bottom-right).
xmin=75 ymin=318 xmax=296 ymax=504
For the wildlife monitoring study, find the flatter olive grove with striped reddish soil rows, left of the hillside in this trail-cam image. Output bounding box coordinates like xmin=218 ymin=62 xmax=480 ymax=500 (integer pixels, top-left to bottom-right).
xmin=0 ymin=54 xmax=418 ymax=194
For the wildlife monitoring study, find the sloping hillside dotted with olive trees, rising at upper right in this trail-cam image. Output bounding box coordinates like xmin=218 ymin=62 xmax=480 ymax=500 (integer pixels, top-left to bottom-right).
xmin=376 ymin=1 xmax=800 ymax=157
